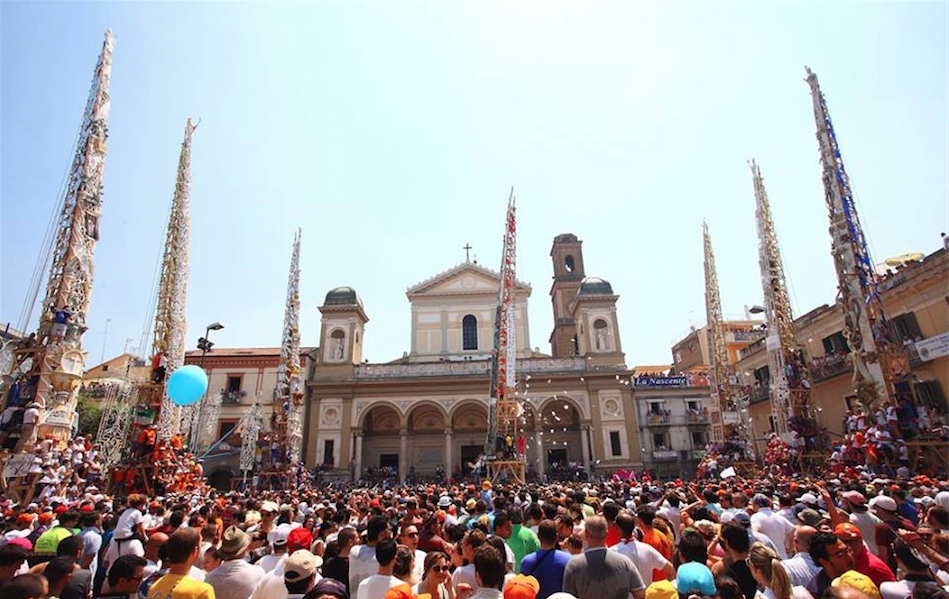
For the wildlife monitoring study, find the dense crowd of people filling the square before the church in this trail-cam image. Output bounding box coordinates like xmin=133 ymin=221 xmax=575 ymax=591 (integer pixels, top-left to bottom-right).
xmin=0 ymin=439 xmax=949 ymax=599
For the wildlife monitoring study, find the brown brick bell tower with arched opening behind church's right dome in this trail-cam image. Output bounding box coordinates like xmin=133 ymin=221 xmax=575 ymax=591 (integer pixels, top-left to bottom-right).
xmin=550 ymin=233 xmax=586 ymax=358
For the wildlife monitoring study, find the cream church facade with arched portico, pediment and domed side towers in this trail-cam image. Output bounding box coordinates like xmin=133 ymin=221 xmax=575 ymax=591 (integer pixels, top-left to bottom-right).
xmin=303 ymin=234 xmax=656 ymax=478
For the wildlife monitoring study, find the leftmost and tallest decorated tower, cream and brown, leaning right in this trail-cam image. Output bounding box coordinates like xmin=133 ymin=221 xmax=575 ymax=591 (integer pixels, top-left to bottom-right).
xmin=29 ymin=31 xmax=115 ymax=448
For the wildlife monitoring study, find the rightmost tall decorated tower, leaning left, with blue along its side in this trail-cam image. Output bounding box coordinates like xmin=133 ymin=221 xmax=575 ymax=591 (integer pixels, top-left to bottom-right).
xmin=807 ymin=69 xmax=889 ymax=406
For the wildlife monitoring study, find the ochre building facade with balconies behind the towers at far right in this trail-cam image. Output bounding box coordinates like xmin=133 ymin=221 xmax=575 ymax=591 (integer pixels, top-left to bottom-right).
xmin=736 ymin=249 xmax=949 ymax=449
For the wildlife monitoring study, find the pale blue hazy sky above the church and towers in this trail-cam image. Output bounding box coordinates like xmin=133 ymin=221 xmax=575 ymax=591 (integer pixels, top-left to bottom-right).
xmin=0 ymin=2 xmax=949 ymax=366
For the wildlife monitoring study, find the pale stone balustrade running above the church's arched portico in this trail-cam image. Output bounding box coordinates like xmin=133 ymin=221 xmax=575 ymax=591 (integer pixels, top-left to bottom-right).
xmin=355 ymin=356 xmax=587 ymax=379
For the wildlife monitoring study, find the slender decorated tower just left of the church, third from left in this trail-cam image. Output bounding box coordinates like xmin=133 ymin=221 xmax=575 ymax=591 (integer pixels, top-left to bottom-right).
xmin=273 ymin=229 xmax=303 ymax=475
